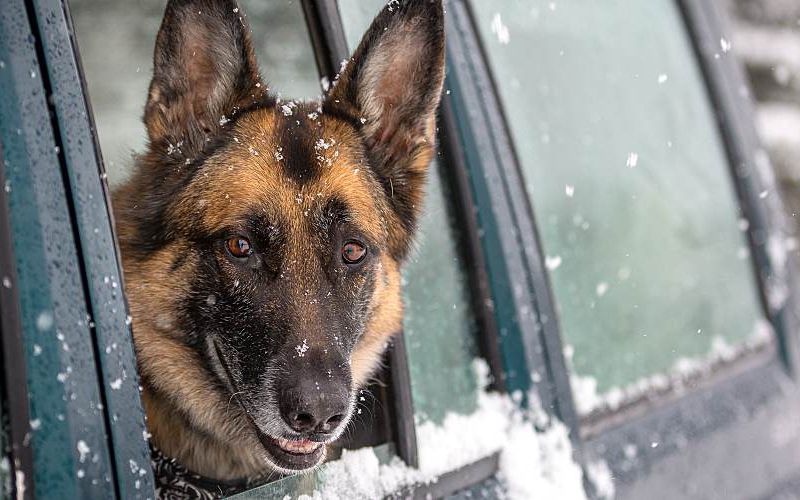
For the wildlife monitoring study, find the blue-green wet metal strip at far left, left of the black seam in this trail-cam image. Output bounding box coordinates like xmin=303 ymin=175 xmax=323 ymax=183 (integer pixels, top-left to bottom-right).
xmin=0 ymin=0 xmax=117 ymax=498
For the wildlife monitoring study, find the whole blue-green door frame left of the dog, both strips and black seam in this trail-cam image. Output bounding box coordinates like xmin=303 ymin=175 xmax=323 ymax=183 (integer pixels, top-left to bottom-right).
xmin=0 ymin=0 xmax=153 ymax=498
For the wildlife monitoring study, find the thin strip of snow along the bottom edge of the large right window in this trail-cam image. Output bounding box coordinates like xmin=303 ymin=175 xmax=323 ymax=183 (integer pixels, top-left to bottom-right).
xmin=564 ymin=319 xmax=775 ymax=415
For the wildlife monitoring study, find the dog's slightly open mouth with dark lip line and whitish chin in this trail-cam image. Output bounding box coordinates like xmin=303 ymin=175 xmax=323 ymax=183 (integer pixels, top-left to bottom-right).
xmin=212 ymin=342 xmax=325 ymax=474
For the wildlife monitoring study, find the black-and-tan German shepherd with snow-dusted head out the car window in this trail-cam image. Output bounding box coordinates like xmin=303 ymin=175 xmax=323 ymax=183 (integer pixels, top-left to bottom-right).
xmin=113 ymin=0 xmax=444 ymax=480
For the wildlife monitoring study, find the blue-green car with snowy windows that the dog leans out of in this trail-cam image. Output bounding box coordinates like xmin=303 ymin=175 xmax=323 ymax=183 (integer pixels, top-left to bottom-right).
xmin=0 ymin=0 xmax=800 ymax=499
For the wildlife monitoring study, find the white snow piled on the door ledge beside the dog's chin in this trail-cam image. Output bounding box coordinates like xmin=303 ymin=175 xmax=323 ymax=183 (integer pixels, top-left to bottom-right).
xmin=299 ymin=360 xmax=600 ymax=500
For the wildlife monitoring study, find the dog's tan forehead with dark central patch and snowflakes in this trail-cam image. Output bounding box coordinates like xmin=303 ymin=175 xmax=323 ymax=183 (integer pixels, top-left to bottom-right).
xmin=179 ymin=103 xmax=385 ymax=241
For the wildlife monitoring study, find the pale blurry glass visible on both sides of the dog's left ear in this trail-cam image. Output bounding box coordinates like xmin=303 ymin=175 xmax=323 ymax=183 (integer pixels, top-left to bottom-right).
xmin=70 ymin=0 xmax=320 ymax=187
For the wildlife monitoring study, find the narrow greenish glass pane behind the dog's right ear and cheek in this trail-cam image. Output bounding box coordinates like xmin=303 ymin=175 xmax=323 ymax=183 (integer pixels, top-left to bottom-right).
xmin=339 ymin=0 xmax=477 ymax=423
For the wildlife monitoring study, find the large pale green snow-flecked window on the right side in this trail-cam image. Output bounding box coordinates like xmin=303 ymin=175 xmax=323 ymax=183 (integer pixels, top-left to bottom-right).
xmin=472 ymin=0 xmax=770 ymax=413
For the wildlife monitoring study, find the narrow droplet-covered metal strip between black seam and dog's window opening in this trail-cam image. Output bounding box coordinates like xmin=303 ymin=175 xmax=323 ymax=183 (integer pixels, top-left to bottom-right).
xmin=29 ymin=0 xmax=154 ymax=498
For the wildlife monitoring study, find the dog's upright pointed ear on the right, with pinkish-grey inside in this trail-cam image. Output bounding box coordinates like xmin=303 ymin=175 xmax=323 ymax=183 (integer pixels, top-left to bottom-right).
xmin=324 ymin=0 xmax=445 ymax=242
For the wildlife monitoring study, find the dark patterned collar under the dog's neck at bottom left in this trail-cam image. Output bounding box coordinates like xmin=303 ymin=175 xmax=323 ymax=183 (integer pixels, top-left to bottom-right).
xmin=150 ymin=444 xmax=250 ymax=500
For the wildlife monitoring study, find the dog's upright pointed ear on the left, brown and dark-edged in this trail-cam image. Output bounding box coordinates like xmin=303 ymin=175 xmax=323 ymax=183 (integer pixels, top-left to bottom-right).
xmin=144 ymin=0 xmax=266 ymax=158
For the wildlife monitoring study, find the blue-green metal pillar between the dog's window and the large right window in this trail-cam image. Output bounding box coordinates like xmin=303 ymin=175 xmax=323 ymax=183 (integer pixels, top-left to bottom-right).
xmin=447 ymin=0 xmax=578 ymax=430
